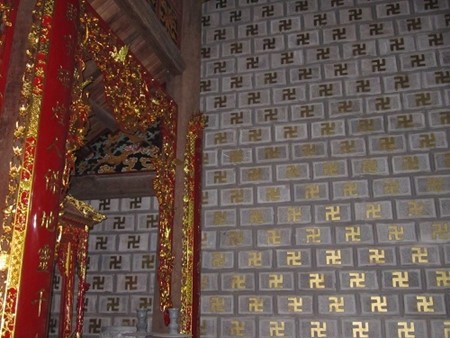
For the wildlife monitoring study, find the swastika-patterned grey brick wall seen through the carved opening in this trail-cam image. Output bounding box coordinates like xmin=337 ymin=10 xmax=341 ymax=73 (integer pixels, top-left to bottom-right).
xmin=49 ymin=197 xmax=158 ymax=338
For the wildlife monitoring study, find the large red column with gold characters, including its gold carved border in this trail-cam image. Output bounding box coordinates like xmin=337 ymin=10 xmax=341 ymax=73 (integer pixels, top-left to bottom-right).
xmin=0 ymin=0 xmax=79 ymax=338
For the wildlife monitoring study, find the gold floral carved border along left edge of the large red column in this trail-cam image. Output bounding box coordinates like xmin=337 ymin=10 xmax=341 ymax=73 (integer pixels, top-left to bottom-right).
xmin=0 ymin=0 xmax=54 ymax=337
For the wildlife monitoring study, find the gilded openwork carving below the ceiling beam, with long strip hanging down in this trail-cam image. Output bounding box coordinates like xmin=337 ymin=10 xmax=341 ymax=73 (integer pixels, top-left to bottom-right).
xmin=81 ymin=1 xmax=177 ymax=311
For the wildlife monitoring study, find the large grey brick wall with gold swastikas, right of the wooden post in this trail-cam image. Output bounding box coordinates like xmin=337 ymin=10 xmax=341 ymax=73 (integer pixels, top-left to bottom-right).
xmin=201 ymin=0 xmax=450 ymax=338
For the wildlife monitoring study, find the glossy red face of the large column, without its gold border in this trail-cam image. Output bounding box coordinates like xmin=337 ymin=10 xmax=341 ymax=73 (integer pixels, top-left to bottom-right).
xmin=14 ymin=0 xmax=79 ymax=337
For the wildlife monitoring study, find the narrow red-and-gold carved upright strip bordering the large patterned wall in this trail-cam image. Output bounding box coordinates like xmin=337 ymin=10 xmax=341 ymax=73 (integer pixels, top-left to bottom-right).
xmin=180 ymin=114 xmax=206 ymax=333
